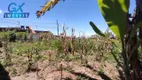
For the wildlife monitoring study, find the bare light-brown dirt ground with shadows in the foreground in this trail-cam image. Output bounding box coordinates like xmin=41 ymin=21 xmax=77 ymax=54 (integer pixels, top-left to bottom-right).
xmin=10 ymin=50 xmax=121 ymax=80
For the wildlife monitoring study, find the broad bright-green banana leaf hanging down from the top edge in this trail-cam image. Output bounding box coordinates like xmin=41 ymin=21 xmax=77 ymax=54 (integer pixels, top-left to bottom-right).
xmin=98 ymin=0 xmax=130 ymax=40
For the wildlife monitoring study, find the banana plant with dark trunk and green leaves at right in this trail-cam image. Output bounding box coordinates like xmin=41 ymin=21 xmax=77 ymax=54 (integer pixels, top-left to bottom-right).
xmin=90 ymin=0 xmax=142 ymax=80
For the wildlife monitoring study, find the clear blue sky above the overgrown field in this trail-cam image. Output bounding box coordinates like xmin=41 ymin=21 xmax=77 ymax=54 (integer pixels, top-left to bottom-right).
xmin=0 ymin=0 xmax=135 ymax=36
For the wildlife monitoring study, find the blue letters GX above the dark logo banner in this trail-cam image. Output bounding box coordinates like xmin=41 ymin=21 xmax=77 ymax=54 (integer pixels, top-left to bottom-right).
xmin=8 ymin=3 xmax=25 ymax=12
